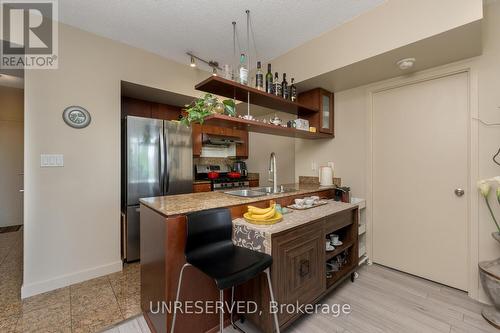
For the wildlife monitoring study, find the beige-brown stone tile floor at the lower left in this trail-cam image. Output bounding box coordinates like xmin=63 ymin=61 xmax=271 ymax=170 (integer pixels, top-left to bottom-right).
xmin=0 ymin=230 xmax=141 ymax=333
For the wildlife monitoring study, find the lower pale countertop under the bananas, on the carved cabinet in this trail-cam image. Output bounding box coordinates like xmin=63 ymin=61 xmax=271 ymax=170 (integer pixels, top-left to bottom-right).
xmin=233 ymin=200 xmax=357 ymax=235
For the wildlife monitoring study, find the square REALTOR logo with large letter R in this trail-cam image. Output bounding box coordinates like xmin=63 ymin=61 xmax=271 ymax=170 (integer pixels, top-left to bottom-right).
xmin=0 ymin=0 xmax=58 ymax=69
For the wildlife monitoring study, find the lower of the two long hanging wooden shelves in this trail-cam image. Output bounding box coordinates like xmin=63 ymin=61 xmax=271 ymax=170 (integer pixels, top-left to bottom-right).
xmin=203 ymin=114 xmax=332 ymax=139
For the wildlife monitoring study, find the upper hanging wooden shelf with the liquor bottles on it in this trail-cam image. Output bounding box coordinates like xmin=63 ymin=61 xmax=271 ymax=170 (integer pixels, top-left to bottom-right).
xmin=195 ymin=76 xmax=319 ymax=114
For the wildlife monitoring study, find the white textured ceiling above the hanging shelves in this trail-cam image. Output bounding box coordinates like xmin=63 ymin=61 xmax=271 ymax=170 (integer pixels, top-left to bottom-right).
xmin=59 ymin=0 xmax=385 ymax=65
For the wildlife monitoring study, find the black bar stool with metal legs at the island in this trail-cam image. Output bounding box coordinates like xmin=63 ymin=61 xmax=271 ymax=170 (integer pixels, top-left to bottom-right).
xmin=170 ymin=208 xmax=280 ymax=333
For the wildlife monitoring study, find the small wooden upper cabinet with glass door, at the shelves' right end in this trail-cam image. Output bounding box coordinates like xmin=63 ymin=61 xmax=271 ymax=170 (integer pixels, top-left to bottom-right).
xmin=298 ymin=88 xmax=334 ymax=136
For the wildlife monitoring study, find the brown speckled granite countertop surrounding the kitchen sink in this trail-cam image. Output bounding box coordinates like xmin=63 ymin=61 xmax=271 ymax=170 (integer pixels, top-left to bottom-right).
xmin=140 ymin=184 xmax=334 ymax=216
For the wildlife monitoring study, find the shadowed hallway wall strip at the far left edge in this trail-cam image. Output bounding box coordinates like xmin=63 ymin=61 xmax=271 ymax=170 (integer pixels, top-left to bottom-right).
xmin=0 ymin=86 xmax=24 ymax=227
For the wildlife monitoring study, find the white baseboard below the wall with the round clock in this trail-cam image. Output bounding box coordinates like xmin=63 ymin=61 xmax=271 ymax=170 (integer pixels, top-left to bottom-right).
xmin=21 ymin=260 xmax=123 ymax=298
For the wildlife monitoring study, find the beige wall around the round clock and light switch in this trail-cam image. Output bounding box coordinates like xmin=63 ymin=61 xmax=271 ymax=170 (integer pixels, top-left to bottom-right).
xmin=22 ymin=24 xmax=207 ymax=297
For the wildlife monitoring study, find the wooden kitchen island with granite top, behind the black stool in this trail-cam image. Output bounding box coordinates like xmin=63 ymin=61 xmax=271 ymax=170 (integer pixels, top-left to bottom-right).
xmin=141 ymin=184 xmax=358 ymax=332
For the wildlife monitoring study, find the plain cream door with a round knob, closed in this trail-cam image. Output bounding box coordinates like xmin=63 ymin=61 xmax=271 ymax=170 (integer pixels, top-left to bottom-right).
xmin=372 ymin=73 xmax=470 ymax=290
